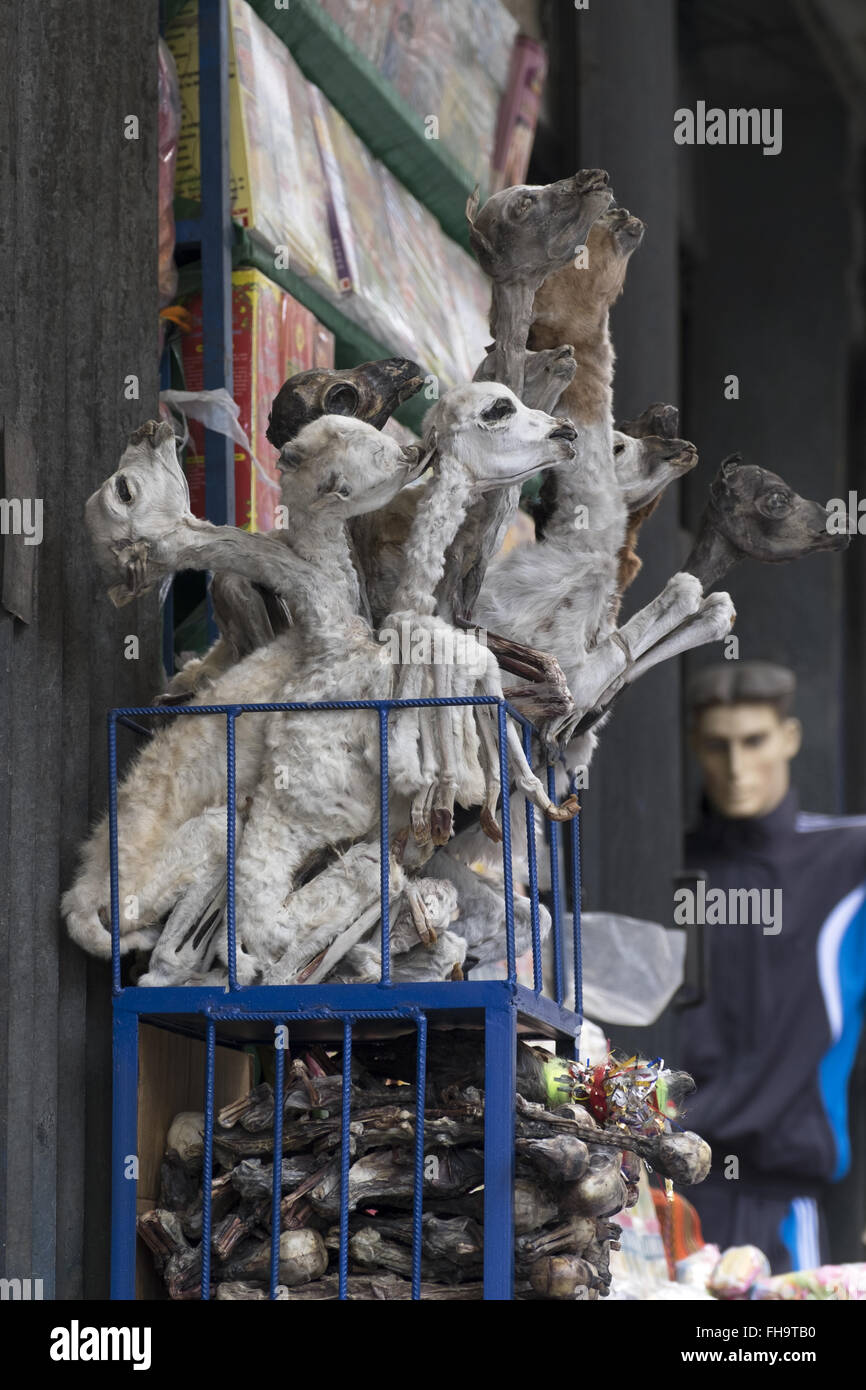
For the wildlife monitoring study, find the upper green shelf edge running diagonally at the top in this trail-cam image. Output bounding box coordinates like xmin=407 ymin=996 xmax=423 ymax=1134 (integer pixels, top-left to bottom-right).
xmin=250 ymin=0 xmax=485 ymax=250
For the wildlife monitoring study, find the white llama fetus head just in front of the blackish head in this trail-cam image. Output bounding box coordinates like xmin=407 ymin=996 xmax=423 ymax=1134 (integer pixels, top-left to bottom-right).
xmin=277 ymin=414 xmax=431 ymax=521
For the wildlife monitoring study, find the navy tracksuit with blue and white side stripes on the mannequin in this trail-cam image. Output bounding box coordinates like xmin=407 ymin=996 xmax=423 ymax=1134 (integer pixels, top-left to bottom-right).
xmin=677 ymin=791 xmax=866 ymax=1273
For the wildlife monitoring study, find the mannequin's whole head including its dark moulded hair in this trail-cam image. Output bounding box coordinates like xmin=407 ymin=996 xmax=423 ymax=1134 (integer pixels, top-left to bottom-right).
xmin=688 ymin=662 xmax=802 ymax=820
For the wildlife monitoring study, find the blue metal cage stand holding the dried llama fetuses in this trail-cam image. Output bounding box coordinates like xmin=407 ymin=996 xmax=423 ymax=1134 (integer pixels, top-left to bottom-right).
xmin=108 ymin=696 xmax=582 ymax=1300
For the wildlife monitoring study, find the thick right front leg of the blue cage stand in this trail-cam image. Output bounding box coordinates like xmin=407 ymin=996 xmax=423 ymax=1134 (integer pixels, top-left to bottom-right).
xmin=484 ymin=1004 xmax=517 ymax=1301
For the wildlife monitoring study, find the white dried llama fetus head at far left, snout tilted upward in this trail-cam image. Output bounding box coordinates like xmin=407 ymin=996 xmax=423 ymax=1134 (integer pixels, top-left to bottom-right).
xmin=85 ymin=420 xmax=190 ymax=605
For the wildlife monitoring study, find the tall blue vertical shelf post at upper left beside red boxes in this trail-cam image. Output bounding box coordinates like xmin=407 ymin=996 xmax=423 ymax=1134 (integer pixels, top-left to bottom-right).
xmin=199 ymin=0 xmax=235 ymax=525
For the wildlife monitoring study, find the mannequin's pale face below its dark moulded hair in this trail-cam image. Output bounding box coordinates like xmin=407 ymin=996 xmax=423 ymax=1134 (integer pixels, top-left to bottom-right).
xmin=691 ymin=703 xmax=801 ymax=820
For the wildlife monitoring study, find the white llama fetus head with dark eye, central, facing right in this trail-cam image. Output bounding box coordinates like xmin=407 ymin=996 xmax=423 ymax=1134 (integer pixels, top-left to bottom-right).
xmin=424 ymin=381 xmax=578 ymax=492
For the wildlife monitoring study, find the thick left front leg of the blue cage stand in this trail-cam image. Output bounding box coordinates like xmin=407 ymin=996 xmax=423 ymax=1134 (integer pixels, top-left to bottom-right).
xmin=111 ymin=1011 xmax=139 ymax=1298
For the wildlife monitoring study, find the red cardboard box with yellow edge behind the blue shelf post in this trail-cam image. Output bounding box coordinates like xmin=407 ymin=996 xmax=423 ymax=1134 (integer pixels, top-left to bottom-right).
xmin=183 ymin=268 xmax=334 ymax=531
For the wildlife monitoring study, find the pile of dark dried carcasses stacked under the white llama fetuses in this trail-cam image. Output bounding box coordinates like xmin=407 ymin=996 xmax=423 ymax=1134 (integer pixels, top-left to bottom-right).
xmin=139 ymin=1030 xmax=710 ymax=1300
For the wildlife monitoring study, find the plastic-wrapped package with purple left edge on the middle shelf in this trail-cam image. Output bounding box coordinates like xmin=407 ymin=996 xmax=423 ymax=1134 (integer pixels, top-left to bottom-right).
xmin=314 ymin=93 xmax=414 ymax=357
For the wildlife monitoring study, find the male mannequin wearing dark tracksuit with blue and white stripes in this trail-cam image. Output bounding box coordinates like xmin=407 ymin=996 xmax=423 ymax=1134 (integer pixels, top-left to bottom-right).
xmin=678 ymin=662 xmax=866 ymax=1273
